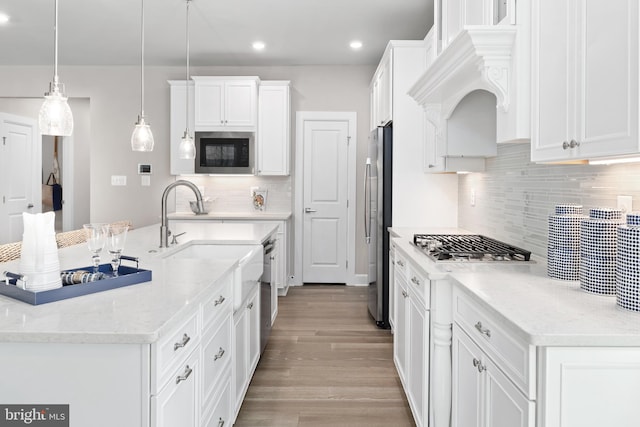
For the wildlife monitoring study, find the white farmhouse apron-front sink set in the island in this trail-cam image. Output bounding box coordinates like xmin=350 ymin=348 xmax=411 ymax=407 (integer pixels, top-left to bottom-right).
xmin=164 ymin=244 xmax=263 ymax=311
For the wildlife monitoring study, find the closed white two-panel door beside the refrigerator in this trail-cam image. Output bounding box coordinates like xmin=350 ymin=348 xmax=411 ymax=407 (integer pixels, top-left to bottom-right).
xmin=301 ymin=121 xmax=349 ymax=283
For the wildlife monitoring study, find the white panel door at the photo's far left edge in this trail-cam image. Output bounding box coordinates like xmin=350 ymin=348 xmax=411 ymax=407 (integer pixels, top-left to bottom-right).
xmin=0 ymin=113 xmax=42 ymax=243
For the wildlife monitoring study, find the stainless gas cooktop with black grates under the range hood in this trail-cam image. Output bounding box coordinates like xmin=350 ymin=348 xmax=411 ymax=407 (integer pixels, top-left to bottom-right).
xmin=413 ymin=234 xmax=531 ymax=262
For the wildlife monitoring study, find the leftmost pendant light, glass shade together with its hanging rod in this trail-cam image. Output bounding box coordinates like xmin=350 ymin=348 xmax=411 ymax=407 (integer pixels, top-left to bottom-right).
xmin=38 ymin=0 xmax=73 ymax=136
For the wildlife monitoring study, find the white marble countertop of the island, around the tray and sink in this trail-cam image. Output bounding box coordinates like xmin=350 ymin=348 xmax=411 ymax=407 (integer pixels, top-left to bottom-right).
xmin=0 ymin=223 xmax=277 ymax=343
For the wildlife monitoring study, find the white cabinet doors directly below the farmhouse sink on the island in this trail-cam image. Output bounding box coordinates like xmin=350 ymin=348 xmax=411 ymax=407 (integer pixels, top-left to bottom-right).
xmin=233 ymin=282 xmax=260 ymax=419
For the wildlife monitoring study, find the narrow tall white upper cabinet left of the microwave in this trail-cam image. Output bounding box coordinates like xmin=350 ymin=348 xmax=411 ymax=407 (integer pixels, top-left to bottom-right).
xmin=169 ymin=80 xmax=195 ymax=175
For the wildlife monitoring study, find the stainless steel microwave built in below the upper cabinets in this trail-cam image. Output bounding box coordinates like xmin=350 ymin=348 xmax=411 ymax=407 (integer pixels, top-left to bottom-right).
xmin=195 ymin=132 xmax=255 ymax=175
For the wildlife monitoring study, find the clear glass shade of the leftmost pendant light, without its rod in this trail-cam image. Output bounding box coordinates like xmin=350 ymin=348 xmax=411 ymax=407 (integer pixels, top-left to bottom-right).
xmin=38 ymin=83 xmax=73 ymax=136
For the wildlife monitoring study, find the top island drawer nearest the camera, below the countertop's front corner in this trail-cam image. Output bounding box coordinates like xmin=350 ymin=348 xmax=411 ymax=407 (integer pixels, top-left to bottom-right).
xmin=152 ymin=312 xmax=200 ymax=390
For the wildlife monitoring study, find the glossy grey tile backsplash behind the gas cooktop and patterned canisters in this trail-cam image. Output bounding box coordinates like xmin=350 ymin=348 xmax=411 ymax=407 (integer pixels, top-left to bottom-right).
xmin=458 ymin=143 xmax=640 ymax=256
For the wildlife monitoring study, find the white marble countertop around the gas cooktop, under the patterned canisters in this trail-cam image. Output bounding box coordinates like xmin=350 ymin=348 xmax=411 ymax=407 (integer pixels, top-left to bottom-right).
xmin=393 ymin=228 xmax=640 ymax=347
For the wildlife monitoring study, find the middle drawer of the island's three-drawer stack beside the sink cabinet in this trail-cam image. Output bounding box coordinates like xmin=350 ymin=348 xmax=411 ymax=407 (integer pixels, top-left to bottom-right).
xmin=201 ymin=314 xmax=233 ymax=408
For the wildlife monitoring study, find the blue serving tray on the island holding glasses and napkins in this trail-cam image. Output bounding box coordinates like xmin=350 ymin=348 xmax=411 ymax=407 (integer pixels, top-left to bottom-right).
xmin=0 ymin=264 xmax=151 ymax=305
